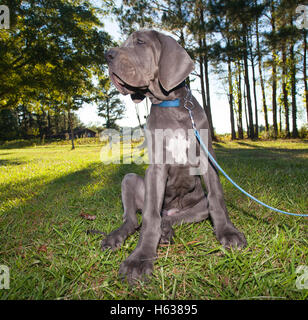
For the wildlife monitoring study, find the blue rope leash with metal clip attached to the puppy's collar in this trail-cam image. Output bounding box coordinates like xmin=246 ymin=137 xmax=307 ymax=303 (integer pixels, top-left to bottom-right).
xmin=184 ymin=91 xmax=308 ymax=217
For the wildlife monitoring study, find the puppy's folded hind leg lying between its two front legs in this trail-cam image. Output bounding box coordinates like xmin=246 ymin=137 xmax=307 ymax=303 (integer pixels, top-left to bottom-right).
xmin=160 ymin=196 xmax=209 ymax=244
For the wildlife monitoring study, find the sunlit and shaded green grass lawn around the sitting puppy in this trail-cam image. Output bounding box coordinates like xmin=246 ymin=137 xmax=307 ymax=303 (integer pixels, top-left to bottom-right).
xmin=0 ymin=140 xmax=308 ymax=299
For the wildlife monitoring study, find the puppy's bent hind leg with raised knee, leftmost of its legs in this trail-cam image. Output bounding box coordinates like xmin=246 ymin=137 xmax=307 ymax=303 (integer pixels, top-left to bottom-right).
xmin=102 ymin=173 xmax=145 ymax=250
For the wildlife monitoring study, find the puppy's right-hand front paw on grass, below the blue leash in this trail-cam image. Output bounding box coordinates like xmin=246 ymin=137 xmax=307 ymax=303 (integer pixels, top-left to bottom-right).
xmin=216 ymin=225 xmax=247 ymax=249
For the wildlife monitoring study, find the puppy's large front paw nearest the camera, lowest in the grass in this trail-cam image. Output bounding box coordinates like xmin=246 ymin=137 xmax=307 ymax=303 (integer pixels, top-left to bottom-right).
xmin=119 ymin=254 xmax=155 ymax=283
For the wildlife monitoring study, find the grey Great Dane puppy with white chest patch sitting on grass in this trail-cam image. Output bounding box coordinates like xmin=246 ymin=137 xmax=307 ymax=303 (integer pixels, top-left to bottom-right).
xmin=102 ymin=30 xmax=246 ymax=281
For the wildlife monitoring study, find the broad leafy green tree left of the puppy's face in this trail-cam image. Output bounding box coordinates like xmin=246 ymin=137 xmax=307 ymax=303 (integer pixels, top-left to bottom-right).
xmin=0 ymin=0 xmax=111 ymax=146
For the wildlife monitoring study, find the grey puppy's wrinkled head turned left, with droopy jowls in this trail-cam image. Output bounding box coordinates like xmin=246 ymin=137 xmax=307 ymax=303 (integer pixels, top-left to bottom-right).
xmin=105 ymin=30 xmax=194 ymax=102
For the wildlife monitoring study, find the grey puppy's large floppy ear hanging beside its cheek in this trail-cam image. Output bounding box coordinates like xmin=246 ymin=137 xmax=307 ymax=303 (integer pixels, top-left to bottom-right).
xmin=158 ymin=33 xmax=194 ymax=92
